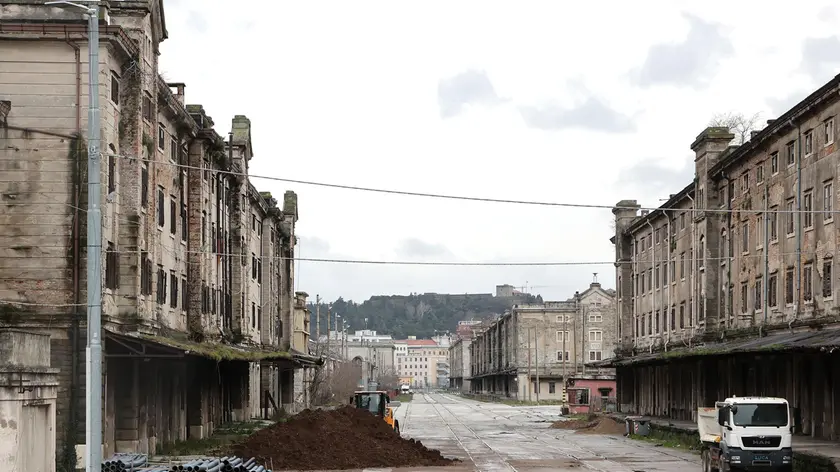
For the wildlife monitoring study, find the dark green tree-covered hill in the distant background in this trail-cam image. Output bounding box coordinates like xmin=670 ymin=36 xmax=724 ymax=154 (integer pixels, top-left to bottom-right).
xmin=308 ymin=293 xmax=542 ymax=339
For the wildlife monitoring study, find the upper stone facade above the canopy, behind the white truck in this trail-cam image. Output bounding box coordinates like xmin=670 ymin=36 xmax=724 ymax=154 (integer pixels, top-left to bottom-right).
xmin=613 ymin=74 xmax=840 ymax=349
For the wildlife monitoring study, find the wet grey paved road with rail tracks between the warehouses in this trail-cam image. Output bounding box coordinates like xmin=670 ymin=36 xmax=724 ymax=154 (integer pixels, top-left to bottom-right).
xmin=388 ymin=394 xmax=701 ymax=472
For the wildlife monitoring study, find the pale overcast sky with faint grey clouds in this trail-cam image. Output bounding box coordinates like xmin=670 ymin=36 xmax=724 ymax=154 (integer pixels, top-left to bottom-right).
xmin=161 ymin=0 xmax=840 ymax=301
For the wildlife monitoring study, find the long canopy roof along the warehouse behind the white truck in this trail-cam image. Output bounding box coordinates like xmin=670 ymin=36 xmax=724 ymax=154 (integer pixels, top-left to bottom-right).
xmin=587 ymin=328 xmax=840 ymax=367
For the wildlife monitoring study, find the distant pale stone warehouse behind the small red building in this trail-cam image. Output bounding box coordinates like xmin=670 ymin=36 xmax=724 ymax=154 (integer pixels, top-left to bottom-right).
xmin=469 ymin=282 xmax=617 ymax=405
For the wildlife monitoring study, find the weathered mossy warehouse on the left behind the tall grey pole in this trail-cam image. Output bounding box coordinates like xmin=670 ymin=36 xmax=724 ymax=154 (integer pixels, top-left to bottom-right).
xmin=0 ymin=0 xmax=316 ymax=470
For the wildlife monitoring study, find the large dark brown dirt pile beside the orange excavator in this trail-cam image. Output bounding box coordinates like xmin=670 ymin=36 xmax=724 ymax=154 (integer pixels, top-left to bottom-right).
xmin=232 ymin=406 xmax=459 ymax=470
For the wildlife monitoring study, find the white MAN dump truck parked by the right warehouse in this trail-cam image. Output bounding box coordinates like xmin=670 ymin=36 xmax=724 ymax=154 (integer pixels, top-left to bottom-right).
xmin=697 ymin=396 xmax=793 ymax=472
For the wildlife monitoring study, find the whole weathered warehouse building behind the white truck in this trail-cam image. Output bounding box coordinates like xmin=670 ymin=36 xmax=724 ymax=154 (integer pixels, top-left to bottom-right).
xmin=604 ymin=76 xmax=840 ymax=438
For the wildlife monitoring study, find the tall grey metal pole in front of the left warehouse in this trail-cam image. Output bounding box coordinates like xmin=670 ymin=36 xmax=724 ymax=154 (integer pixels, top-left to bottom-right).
xmin=46 ymin=0 xmax=102 ymax=472
